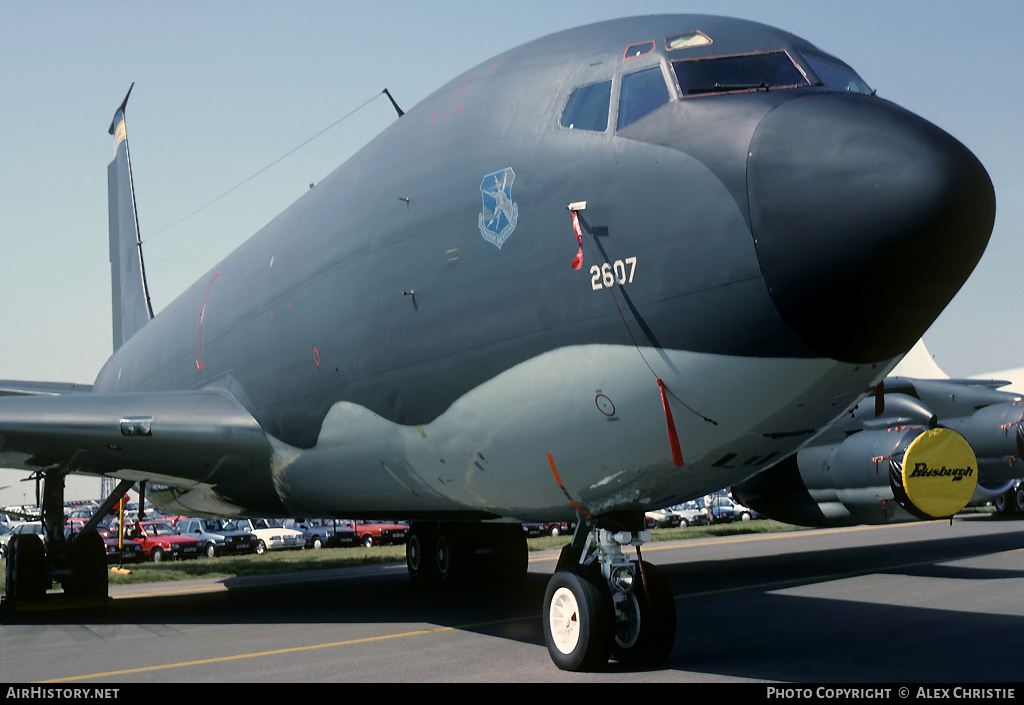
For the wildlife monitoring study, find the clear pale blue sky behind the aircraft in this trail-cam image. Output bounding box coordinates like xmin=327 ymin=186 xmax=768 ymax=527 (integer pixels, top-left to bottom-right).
xmin=0 ymin=0 xmax=1024 ymax=502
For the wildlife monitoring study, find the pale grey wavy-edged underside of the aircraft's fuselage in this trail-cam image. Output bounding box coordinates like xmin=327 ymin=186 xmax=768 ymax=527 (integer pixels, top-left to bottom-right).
xmin=272 ymin=345 xmax=885 ymax=521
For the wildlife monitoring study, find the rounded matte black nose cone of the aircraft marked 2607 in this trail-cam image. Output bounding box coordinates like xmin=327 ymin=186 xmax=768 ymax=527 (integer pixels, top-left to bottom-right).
xmin=746 ymin=94 xmax=995 ymax=363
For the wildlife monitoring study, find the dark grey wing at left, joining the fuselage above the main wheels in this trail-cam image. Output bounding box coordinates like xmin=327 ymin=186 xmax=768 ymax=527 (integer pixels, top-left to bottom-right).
xmin=0 ymin=385 xmax=280 ymax=510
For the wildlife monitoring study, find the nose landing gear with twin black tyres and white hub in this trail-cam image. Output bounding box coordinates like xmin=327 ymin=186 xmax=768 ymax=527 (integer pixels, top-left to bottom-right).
xmin=544 ymin=515 xmax=676 ymax=671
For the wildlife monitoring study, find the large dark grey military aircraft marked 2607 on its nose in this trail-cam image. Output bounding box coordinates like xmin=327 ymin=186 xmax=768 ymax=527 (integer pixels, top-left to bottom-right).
xmin=0 ymin=15 xmax=995 ymax=669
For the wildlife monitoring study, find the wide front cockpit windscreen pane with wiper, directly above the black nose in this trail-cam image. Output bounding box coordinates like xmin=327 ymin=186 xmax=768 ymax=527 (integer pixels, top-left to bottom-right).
xmin=672 ymin=51 xmax=811 ymax=95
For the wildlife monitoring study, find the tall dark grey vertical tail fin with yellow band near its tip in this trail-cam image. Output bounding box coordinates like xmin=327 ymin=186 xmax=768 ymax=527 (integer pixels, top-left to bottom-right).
xmin=106 ymin=83 xmax=153 ymax=350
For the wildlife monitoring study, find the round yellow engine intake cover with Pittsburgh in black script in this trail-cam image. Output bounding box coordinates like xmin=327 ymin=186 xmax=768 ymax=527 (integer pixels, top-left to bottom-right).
xmin=902 ymin=428 xmax=978 ymax=517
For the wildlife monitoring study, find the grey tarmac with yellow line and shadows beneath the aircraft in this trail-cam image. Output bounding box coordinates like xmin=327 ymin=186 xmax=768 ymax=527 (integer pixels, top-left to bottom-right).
xmin=0 ymin=515 xmax=1024 ymax=692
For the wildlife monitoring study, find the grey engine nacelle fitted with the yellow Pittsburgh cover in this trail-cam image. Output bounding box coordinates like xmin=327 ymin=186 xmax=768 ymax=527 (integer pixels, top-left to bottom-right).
xmin=732 ymin=426 xmax=978 ymax=527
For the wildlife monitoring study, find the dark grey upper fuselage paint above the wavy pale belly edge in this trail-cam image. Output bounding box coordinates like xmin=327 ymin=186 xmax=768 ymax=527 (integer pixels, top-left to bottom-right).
xmin=97 ymin=18 xmax=823 ymax=448
